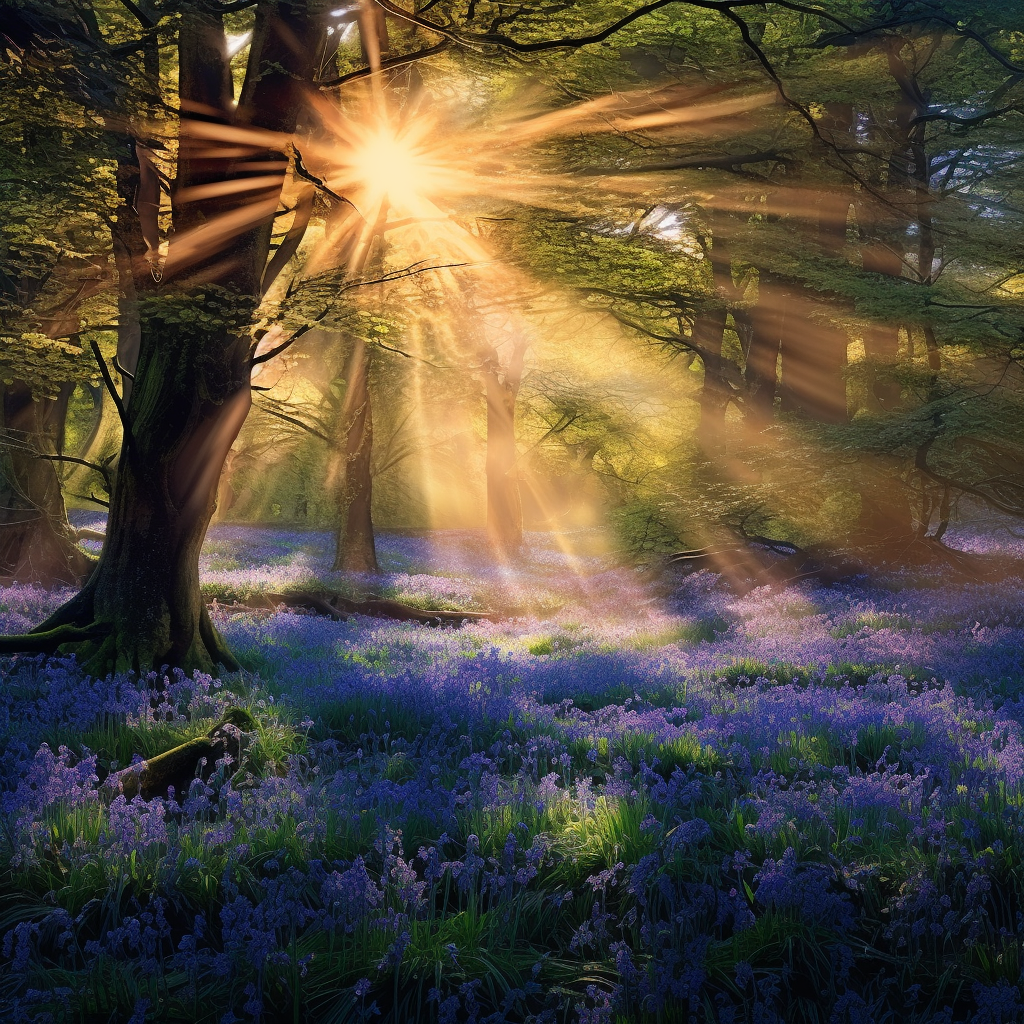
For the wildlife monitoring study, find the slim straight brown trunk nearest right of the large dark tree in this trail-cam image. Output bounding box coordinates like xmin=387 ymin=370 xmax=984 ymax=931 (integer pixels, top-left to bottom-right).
xmin=334 ymin=338 xmax=380 ymax=572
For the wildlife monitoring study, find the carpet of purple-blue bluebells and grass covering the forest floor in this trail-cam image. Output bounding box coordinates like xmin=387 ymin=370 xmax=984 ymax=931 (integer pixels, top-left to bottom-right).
xmin=0 ymin=526 xmax=1024 ymax=1024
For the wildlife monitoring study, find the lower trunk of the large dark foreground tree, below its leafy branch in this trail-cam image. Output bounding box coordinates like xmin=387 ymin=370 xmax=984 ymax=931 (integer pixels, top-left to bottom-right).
xmin=34 ymin=299 xmax=251 ymax=673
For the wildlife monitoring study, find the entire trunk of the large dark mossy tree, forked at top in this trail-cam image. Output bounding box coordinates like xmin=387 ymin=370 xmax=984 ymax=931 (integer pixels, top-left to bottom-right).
xmin=0 ymin=2 xmax=318 ymax=674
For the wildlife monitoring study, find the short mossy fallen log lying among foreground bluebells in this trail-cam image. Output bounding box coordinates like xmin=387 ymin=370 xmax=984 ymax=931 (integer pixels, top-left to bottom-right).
xmin=99 ymin=708 xmax=256 ymax=800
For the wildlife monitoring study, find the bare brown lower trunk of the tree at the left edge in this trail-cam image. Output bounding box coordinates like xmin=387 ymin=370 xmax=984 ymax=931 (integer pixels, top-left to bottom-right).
xmin=0 ymin=381 xmax=94 ymax=587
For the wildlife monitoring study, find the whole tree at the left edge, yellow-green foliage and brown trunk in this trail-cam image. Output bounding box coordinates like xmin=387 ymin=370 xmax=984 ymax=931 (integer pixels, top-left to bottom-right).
xmin=0 ymin=54 xmax=113 ymax=586
